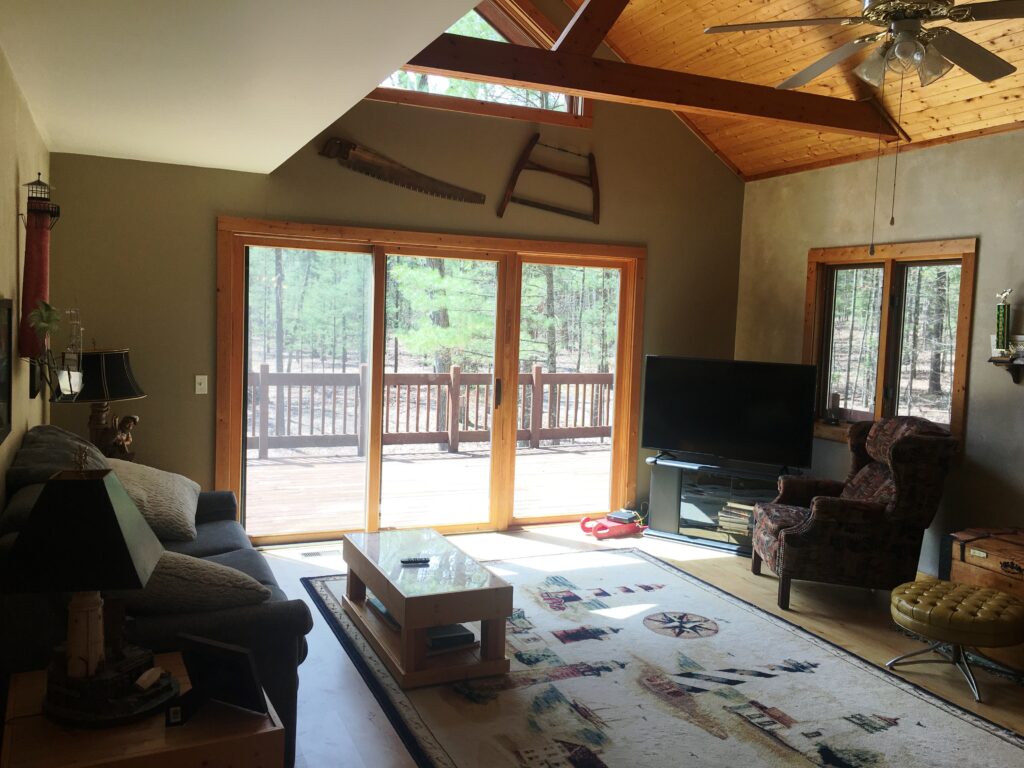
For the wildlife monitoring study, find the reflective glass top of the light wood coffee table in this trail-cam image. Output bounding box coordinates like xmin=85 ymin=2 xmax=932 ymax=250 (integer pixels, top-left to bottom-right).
xmin=345 ymin=528 xmax=508 ymax=597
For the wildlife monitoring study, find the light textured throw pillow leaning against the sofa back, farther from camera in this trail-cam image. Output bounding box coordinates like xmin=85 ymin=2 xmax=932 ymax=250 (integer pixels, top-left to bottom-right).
xmin=110 ymin=459 xmax=200 ymax=542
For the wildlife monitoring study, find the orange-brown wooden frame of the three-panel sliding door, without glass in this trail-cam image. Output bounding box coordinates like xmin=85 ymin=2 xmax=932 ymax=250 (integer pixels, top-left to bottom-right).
xmin=214 ymin=216 xmax=647 ymax=543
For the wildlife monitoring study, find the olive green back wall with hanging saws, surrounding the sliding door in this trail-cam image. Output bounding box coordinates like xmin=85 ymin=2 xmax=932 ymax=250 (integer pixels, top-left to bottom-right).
xmin=52 ymin=101 xmax=743 ymax=496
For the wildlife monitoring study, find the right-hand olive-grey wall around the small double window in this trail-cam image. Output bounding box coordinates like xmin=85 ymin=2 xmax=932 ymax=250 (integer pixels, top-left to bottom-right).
xmin=735 ymin=131 xmax=1024 ymax=573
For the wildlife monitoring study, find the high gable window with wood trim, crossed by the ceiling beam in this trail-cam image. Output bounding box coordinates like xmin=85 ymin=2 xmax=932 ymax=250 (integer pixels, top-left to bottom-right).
xmin=367 ymin=0 xmax=591 ymax=127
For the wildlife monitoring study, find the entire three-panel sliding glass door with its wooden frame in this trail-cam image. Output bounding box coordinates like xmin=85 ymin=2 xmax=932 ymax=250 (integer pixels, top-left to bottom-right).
xmin=215 ymin=219 xmax=643 ymax=543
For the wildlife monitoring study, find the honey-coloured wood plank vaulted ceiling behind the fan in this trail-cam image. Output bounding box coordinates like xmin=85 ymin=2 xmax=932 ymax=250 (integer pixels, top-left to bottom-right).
xmin=567 ymin=0 xmax=1024 ymax=179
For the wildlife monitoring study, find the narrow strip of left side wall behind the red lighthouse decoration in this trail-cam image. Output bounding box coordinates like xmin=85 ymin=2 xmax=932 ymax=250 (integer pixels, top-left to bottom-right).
xmin=0 ymin=45 xmax=47 ymax=498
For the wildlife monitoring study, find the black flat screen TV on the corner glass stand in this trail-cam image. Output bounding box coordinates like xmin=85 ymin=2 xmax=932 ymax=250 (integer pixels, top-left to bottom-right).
xmin=641 ymin=354 xmax=817 ymax=467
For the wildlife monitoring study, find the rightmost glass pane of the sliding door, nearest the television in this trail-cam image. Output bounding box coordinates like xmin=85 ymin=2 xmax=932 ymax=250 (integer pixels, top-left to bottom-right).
xmin=513 ymin=263 xmax=620 ymax=522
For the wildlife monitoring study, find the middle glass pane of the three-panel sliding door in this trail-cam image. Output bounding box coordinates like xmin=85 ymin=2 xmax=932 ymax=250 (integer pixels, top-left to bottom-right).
xmin=380 ymin=254 xmax=498 ymax=527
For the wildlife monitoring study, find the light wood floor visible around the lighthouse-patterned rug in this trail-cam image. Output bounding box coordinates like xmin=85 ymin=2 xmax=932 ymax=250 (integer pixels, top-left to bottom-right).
xmin=266 ymin=525 xmax=1024 ymax=768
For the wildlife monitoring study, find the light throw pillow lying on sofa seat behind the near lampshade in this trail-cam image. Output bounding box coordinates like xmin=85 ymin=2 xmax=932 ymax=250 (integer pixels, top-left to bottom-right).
xmin=117 ymin=552 xmax=270 ymax=613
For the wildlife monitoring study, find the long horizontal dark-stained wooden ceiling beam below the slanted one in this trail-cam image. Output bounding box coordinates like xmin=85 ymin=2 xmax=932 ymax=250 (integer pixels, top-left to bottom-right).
xmin=407 ymin=34 xmax=897 ymax=141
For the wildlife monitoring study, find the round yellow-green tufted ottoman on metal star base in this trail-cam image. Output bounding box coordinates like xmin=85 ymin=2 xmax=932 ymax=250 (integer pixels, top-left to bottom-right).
xmin=886 ymin=580 xmax=1024 ymax=701
